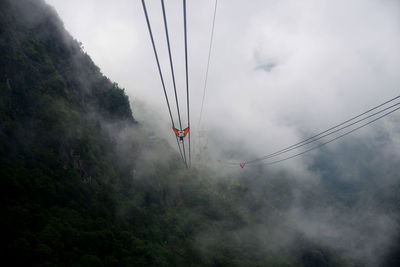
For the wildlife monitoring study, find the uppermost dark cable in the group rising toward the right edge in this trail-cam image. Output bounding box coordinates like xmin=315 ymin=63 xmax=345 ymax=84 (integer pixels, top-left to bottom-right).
xmin=245 ymin=96 xmax=400 ymax=164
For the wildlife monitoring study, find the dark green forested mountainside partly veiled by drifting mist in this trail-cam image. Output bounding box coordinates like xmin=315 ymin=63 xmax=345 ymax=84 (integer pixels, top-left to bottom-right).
xmin=0 ymin=0 xmax=400 ymax=266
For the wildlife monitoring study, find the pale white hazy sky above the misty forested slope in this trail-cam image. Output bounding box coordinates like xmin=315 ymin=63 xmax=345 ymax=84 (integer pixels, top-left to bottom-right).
xmin=46 ymin=0 xmax=400 ymax=168
